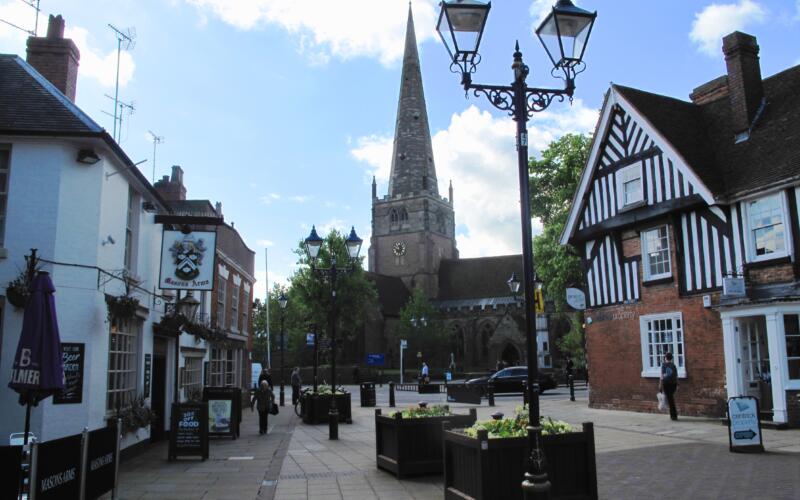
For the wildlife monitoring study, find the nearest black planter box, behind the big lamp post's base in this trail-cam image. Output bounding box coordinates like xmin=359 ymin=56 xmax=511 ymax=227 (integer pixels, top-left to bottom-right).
xmin=443 ymin=423 xmax=597 ymax=500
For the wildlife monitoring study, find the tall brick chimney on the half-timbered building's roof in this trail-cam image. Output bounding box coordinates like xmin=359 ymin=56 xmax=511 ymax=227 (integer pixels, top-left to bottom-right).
xmin=722 ymin=31 xmax=764 ymax=134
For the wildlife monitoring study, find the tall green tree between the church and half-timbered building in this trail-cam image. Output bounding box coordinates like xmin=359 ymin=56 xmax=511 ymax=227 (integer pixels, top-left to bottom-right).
xmin=529 ymin=134 xmax=591 ymax=366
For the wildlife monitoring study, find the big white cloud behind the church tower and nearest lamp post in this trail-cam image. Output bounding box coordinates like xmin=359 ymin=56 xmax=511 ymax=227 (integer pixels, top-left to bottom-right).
xmin=351 ymin=99 xmax=597 ymax=257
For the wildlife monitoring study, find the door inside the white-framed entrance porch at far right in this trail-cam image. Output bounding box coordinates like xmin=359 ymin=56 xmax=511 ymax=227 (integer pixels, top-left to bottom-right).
xmin=739 ymin=317 xmax=770 ymax=398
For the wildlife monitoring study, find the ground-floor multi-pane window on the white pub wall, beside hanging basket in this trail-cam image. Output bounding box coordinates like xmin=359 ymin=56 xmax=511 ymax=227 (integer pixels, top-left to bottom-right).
xmin=106 ymin=318 xmax=142 ymax=411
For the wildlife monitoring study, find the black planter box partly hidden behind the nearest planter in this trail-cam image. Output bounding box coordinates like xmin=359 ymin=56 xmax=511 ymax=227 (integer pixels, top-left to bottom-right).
xmin=375 ymin=408 xmax=477 ymax=479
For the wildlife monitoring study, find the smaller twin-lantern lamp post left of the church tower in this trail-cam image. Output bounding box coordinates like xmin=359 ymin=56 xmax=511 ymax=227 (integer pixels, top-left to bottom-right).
xmin=305 ymin=226 xmax=363 ymax=439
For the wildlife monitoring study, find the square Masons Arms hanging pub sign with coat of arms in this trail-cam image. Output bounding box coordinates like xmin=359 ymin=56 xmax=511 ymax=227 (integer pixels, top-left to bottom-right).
xmin=158 ymin=229 xmax=217 ymax=290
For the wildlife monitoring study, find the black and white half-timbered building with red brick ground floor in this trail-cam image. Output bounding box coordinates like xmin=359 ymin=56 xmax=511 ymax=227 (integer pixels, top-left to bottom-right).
xmin=562 ymin=32 xmax=800 ymax=425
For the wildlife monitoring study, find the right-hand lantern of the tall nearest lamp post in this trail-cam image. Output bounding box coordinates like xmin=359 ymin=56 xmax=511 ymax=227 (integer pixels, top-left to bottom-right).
xmin=536 ymin=0 xmax=597 ymax=73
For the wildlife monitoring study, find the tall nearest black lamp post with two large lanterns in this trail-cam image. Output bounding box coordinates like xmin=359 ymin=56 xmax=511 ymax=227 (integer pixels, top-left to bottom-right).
xmin=436 ymin=0 xmax=597 ymax=498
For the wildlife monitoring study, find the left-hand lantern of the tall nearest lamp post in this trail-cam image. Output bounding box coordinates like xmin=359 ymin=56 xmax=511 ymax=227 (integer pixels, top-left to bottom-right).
xmin=436 ymin=0 xmax=492 ymax=73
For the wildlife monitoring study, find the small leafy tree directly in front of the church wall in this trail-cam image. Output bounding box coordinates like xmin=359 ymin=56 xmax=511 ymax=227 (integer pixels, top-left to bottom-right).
xmin=395 ymin=288 xmax=449 ymax=368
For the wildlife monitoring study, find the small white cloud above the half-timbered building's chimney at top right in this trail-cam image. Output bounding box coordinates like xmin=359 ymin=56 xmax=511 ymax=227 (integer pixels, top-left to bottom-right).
xmin=689 ymin=0 xmax=767 ymax=57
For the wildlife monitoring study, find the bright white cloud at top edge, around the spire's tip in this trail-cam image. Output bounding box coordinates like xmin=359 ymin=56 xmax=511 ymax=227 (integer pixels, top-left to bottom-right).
xmin=185 ymin=0 xmax=438 ymax=65
